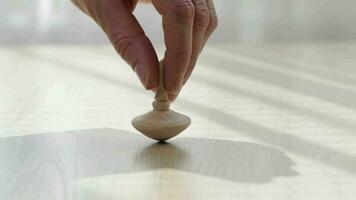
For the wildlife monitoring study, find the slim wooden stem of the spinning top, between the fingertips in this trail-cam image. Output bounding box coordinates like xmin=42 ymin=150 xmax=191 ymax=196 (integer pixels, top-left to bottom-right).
xmin=152 ymin=62 xmax=170 ymax=111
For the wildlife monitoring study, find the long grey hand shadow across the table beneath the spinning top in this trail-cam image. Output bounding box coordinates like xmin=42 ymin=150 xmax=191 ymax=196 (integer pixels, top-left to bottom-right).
xmin=0 ymin=129 xmax=297 ymax=184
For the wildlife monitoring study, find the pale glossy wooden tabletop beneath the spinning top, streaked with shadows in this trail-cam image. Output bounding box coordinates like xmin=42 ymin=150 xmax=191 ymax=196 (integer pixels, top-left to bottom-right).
xmin=0 ymin=41 xmax=356 ymax=200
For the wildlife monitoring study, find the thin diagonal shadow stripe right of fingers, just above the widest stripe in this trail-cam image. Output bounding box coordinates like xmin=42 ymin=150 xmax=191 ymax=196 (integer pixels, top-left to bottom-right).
xmin=202 ymin=49 xmax=356 ymax=110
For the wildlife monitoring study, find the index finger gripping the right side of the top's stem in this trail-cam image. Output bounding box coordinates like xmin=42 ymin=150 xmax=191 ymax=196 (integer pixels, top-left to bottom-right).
xmin=156 ymin=0 xmax=195 ymax=101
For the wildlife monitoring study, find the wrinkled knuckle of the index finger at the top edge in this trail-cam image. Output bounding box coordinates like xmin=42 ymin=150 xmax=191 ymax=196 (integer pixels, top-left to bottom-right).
xmin=171 ymin=0 xmax=195 ymax=22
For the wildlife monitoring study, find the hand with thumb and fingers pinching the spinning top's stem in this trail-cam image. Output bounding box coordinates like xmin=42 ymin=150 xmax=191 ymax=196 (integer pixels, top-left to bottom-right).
xmin=72 ymin=0 xmax=217 ymax=101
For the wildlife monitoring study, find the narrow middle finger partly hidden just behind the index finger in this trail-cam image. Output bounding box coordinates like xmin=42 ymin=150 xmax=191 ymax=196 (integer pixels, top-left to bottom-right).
xmin=183 ymin=0 xmax=210 ymax=84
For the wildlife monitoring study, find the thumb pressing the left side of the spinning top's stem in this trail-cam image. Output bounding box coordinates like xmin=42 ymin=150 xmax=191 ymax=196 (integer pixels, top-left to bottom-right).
xmin=95 ymin=0 xmax=158 ymax=90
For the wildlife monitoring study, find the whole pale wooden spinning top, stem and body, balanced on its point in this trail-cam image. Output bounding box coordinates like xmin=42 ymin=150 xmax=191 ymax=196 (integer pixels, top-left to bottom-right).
xmin=131 ymin=64 xmax=190 ymax=141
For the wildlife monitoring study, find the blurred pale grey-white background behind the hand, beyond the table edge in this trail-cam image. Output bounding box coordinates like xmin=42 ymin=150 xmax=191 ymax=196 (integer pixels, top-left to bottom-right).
xmin=0 ymin=0 xmax=356 ymax=44
